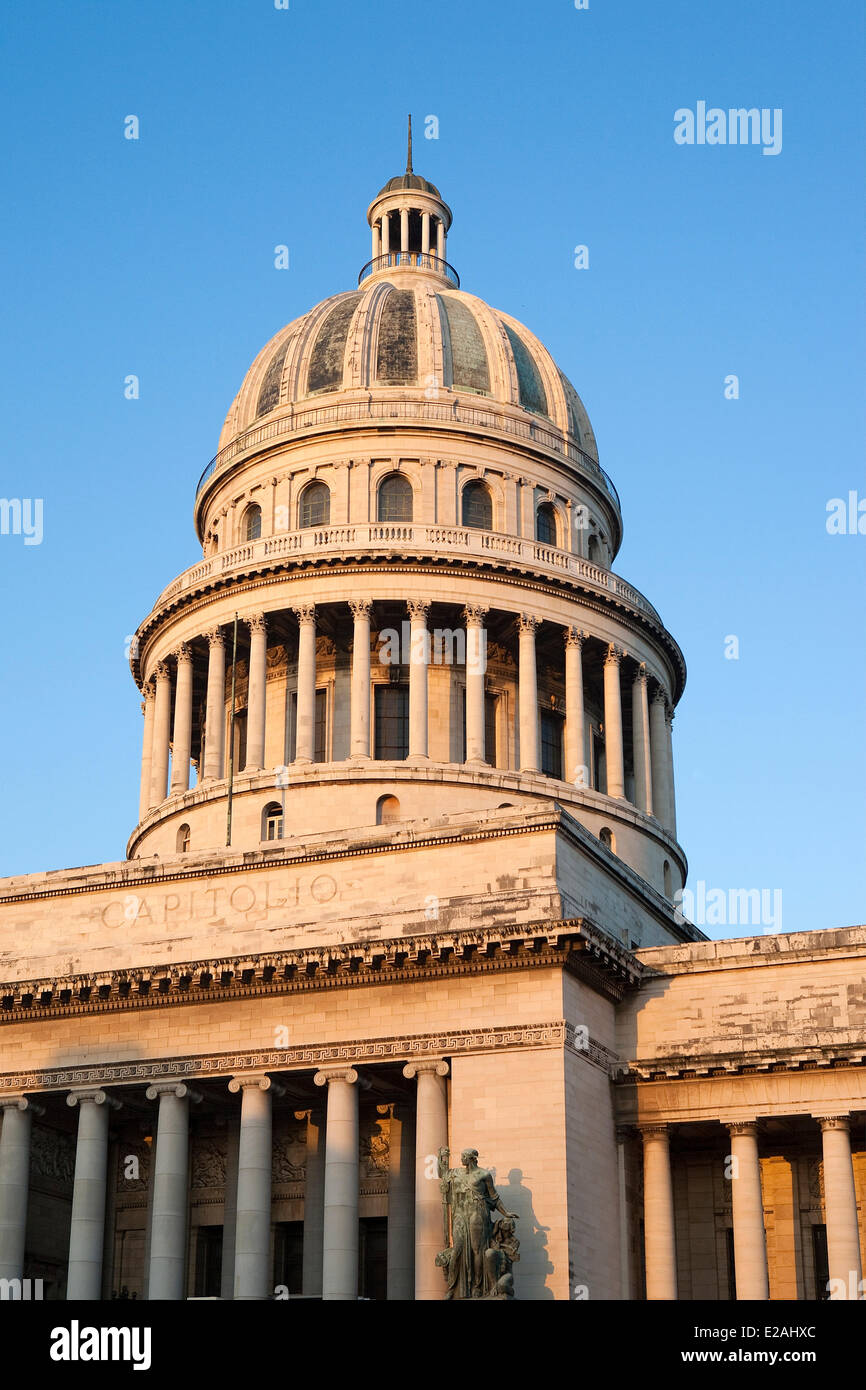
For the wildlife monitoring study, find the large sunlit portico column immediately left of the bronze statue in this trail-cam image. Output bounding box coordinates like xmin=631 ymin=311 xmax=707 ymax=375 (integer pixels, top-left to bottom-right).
xmin=403 ymin=1058 xmax=448 ymax=1301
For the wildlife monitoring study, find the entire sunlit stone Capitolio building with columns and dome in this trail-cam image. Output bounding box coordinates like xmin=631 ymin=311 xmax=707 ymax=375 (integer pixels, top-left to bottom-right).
xmin=0 ymin=135 xmax=866 ymax=1301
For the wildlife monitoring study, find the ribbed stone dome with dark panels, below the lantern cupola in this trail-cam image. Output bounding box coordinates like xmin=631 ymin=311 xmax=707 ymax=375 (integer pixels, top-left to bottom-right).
xmin=220 ymin=278 xmax=598 ymax=463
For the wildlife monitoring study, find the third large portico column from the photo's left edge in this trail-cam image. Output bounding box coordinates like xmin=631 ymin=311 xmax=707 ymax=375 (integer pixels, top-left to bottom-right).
xmin=147 ymin=1081 xmax=200 ymax=1301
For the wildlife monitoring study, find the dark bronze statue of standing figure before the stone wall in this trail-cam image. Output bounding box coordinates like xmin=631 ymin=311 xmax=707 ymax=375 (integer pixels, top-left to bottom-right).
xmin=436 ymin=1148 xmax=520 ymax=1300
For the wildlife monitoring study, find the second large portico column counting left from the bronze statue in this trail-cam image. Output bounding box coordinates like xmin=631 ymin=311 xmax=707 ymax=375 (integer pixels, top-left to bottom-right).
xmin=316 ymin=1066 xmax=360 ymax=1301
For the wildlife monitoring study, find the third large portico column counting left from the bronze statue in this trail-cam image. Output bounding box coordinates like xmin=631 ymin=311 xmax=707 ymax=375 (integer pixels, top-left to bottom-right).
xmin=228 ymin=1072 xmax=282 ymax=1298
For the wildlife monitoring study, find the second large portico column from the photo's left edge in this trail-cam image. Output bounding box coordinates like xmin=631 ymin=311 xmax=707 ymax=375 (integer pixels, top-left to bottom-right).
xmin=67 ymin=1087 xmax=120 ymax=1302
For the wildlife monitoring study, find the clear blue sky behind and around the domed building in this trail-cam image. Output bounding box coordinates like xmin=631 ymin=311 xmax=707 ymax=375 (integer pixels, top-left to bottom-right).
xmin=0 ymin=0 xmax=866 ymax=934
